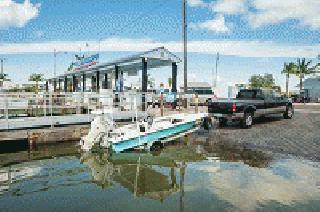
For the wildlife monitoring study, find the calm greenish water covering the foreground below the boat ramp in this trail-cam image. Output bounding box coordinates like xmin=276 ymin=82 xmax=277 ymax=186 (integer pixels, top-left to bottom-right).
xmin=0 ymin=139 xmax=320 ymax=211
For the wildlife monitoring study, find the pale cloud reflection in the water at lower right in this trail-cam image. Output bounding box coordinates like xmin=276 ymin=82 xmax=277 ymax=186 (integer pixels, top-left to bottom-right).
xmin=192 ymin=159 xmax=320 ymax=211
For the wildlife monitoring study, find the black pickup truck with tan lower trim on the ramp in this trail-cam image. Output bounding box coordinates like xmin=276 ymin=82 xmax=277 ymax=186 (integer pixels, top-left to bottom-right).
xmin=208 ymin=89 xmax=294 ymax=128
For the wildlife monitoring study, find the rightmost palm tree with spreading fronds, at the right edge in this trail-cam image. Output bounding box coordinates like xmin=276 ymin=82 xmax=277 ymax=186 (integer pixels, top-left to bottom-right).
xmin=296 ymin=58 xmax=320 ymax=92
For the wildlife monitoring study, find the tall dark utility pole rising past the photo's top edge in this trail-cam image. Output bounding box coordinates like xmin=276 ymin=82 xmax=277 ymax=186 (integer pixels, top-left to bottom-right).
xmin=182 ymin=0 xmax=188 ymax=107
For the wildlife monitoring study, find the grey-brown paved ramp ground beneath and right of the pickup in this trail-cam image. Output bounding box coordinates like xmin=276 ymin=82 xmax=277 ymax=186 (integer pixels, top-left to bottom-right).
xmin=210 ymin=109 xmax=320 ymax=161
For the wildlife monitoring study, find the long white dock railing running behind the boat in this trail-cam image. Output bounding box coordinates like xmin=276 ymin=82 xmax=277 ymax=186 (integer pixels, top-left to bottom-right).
xmin=0 ymin=90 xmax=208 ymax=130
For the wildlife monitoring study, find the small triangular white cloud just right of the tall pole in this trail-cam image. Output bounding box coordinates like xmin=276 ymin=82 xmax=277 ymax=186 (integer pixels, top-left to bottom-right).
xmin=190 ymin=14 xmax=230 ymax=33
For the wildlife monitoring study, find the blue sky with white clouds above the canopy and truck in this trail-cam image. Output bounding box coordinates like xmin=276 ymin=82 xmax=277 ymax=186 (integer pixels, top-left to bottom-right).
xmin=0 ymin=0 xmax=320 ymax=96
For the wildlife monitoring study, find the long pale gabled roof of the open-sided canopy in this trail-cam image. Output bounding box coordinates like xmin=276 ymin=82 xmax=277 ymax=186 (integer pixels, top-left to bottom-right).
xmin=50 ymin=47 xmax=181 ymax=78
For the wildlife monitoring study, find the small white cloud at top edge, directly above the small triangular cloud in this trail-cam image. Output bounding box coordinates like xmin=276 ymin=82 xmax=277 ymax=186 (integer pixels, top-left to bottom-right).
xmin=209 ymin=0 xmax=248 ymax=14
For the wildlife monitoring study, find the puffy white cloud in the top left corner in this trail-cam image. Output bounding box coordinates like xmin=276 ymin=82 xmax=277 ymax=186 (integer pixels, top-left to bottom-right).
xmin=0 ymin=0 xmax=40 ymax=29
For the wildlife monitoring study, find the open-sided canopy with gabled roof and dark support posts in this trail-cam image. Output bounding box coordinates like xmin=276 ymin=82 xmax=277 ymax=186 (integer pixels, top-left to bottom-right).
xmin=47 ymin=47 xmax=181 ymax=92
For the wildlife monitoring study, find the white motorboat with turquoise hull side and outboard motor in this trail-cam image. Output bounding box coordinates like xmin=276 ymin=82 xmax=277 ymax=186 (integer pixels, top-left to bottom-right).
xmin=80 ymin=113 xmax=207 ymax=152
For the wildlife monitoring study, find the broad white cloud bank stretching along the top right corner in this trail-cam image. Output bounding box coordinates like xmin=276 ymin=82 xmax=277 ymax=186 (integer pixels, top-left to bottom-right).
xmin=189 ymin=0 xmax=320 ymax=30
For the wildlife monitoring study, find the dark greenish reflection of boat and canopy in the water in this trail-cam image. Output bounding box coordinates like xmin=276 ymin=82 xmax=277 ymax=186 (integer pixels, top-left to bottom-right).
xmin=81 ymin=146 xmax=205 ymax=202
